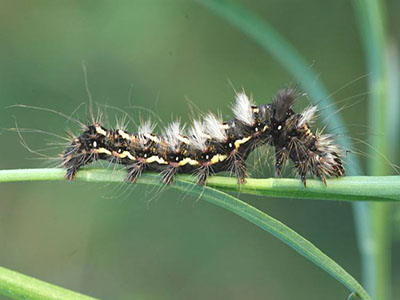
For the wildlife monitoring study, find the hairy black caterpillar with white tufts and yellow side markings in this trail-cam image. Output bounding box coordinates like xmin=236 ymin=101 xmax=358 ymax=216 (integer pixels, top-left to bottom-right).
xmin=63 ymin=88 xmax=344 ymax=186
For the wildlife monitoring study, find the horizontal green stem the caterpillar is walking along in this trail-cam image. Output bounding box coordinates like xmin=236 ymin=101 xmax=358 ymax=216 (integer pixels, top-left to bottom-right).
xmin=0 ymin=169 xmax=400 ymax=202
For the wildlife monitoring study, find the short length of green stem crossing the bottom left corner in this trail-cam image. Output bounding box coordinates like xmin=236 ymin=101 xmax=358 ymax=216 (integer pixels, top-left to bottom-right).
xmin=0 ymin=267 xmax=95 ymax=300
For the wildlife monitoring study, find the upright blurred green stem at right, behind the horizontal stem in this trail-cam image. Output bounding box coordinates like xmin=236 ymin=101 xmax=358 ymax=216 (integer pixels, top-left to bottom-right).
xmin=354 ymin=0 xmax=390 ymax=300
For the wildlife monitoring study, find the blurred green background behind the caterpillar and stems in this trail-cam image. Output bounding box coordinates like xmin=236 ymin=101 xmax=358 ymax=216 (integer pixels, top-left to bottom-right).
xmin=0 ymin=0 xmax=400 ymax=300
